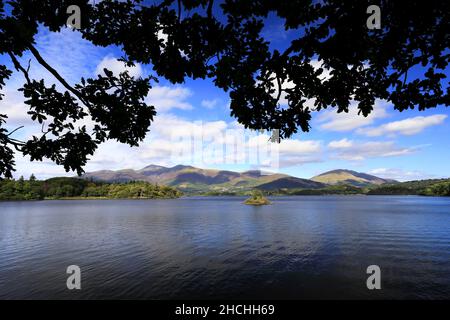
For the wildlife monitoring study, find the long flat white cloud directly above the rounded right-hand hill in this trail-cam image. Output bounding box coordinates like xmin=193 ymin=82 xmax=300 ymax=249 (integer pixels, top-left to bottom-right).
xmin=328 ymin=139 xmax=420 ymax=161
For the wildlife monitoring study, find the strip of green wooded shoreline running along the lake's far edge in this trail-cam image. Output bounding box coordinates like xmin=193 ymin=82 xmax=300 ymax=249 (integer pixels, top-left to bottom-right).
xmin=0 ymin=176 xmax=450 ymax=201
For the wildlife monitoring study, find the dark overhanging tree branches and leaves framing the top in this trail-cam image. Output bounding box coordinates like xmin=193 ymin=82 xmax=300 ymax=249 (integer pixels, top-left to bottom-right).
xmin=0 ymin=0 xmax=450 ymax=178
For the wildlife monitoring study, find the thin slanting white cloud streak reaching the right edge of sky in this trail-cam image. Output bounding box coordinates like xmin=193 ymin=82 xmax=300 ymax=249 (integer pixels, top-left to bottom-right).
xmin=358 ymin=114 xmax=447 ymax=137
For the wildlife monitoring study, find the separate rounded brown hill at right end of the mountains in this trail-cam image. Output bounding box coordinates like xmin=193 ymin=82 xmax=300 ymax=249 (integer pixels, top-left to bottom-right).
xmin=311 ymin=169 xmax=397 ymax=187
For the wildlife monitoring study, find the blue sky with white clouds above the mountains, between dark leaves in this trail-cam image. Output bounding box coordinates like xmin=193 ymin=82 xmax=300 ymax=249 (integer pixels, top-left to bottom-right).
xmin=0 ymin=20 xmax=450 ymax=181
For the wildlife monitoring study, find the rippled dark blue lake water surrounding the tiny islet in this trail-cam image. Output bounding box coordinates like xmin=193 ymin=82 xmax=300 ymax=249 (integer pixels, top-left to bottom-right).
xmin=0 ymin=196 xmax=450 ymax=299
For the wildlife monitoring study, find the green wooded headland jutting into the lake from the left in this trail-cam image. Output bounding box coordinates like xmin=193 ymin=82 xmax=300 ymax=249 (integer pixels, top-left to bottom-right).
xmin=0 ymin=175 xmax=181 ymax=200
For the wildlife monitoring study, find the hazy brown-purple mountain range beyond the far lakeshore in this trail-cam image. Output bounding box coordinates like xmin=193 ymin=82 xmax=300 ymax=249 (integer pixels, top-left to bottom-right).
xmin=83 ymin=165 xmax=396 ymax=193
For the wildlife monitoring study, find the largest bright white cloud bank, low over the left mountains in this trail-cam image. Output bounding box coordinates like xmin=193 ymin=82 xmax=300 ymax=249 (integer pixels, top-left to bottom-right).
xmin=71 ymin=114 xmax=322 ymax=171
